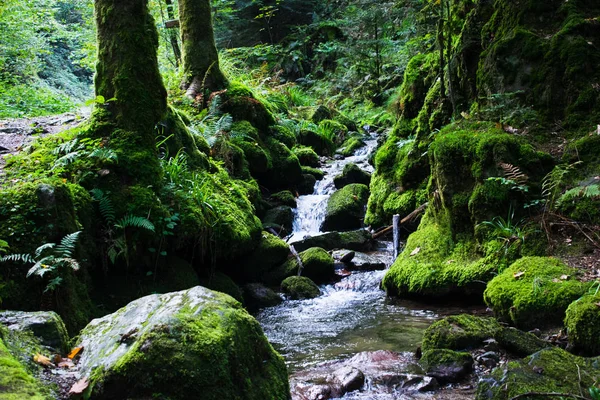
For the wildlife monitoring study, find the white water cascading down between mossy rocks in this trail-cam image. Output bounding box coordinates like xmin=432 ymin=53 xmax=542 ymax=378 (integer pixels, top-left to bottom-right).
xmin=289 ymin=136 xmax=377 ymax=243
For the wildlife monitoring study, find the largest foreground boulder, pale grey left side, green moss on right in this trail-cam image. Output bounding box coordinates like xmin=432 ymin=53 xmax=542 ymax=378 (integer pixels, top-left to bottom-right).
xmin=78 ymin=286 xmax=289 ymax=400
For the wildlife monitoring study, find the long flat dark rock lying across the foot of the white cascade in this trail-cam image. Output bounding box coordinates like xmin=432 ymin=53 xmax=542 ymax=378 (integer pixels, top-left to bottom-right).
xmin=293 ymin=229 xmax=375 ymax=251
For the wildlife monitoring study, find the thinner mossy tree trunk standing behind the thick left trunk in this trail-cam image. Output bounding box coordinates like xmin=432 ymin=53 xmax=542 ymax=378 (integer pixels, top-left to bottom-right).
xmin=179 ymin=0 xmax=227 ymax=98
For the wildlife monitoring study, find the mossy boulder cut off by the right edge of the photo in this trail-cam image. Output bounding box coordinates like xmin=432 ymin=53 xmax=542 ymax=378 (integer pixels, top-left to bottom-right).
xmin=565 ymin=294 xmax=600 ymax=356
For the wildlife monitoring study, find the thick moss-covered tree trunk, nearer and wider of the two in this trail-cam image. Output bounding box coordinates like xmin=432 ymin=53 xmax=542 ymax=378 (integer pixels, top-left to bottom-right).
xmin=88 ymin=0 xmax=167 ymax=185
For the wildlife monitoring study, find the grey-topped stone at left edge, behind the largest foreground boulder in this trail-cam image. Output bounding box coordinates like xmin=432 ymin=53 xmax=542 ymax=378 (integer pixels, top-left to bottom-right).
xmin=0 ymin=311 xmax=69 ymax=353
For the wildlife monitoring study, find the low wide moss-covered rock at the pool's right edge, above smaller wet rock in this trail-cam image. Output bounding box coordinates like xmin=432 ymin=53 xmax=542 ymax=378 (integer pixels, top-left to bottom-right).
xmin=421 ymin=314 xmax=502 ymax=352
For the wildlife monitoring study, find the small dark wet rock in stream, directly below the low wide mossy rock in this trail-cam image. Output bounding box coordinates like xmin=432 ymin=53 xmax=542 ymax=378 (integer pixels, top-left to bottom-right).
xmin=421 ymin=349 xmax=473 ymax=384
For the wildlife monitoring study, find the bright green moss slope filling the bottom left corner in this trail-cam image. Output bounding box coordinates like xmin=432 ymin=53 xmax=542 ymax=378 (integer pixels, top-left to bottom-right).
xmin=0 ymin=334 xmax=52 ymax=400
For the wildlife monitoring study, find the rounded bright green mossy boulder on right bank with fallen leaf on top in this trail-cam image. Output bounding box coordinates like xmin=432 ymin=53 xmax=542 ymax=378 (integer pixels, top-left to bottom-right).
xmin=484 ymin=257 xmax=589 ymax=329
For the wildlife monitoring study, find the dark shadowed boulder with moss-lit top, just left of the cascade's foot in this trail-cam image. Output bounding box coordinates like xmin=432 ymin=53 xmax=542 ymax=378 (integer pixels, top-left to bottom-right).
xmin=236 ymin=231 xmax=290 ymax=282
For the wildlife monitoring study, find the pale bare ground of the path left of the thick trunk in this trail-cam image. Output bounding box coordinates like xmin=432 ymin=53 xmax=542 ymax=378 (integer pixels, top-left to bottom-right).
xmin=0 ymin=107 xmax=91 ymax=175
